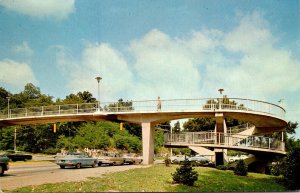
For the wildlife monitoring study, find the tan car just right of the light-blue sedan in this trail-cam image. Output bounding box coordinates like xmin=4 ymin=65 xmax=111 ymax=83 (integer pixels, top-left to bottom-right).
xmin=98 ymin=152 xmax=125 ymax=166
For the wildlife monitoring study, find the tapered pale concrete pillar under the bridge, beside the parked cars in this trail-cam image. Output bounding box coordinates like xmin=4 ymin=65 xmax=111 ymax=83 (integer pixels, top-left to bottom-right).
xmin=142 ymin=122 xmax=155 ymax=165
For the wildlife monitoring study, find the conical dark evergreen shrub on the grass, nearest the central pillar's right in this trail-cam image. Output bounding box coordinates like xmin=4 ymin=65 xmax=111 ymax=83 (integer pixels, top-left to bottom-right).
xmin=172 ymin=159 xmax=199 ymax=186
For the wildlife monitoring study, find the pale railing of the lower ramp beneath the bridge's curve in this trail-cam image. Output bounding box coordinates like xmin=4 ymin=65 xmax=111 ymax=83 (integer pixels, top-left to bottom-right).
xmin=165 ymin=132 xmax=285 ymax=152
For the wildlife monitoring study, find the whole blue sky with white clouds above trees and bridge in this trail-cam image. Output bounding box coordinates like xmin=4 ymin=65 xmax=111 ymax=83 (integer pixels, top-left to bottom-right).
xmin=0 ymin=0 xmax=300 ymax=138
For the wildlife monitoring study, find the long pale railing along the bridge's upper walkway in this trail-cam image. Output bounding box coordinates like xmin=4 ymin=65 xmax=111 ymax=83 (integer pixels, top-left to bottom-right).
xmin=0 ymin=98 xmax=285 ymax=119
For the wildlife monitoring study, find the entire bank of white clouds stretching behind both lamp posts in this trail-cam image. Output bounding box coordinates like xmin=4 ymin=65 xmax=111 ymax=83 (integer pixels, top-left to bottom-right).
xmin=56 ymin=12 xmax=300 ymax=117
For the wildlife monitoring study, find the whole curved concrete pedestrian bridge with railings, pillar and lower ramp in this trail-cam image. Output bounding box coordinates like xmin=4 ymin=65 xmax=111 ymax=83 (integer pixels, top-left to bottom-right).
xmin=0 ymin=98 xmax=287 ymax=167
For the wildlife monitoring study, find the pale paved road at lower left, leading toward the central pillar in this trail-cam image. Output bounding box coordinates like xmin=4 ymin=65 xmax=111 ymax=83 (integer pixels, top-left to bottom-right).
xmin=0 ymin=161 xmax=148 ymax=192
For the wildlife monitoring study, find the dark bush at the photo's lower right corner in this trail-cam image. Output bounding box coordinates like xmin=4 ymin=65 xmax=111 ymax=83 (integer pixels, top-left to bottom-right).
xmin=282 ymin=147 xmax=300 ymax=190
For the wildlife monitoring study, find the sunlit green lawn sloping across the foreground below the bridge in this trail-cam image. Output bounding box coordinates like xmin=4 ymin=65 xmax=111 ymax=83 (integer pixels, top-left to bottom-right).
xmin=5 ymin=165 xmax=286 ymax=193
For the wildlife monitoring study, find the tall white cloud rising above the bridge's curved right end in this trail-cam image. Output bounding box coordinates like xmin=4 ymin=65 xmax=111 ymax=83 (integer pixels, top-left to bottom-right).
xmin=205 ymin=12 xmax=300 ymax=98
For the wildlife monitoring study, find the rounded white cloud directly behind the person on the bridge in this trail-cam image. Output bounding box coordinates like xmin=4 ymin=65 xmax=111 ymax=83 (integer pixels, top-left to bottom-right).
xmin=129 ymin=29 xmax=200 ymax=99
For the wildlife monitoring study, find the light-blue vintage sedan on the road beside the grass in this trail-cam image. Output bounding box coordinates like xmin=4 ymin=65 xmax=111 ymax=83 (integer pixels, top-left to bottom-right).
xmin=56 ymin=153 xmax=98 ymax=169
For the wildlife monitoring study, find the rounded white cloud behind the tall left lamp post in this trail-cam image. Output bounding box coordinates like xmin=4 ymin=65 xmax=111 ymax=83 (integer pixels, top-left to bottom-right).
xmin=57 ymin=43 xmax=132 ymax=101
